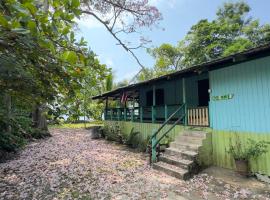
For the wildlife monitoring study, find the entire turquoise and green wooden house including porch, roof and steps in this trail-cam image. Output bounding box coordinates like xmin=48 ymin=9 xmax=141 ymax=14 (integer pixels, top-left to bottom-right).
xmin=93 ymin=45 xmax=270 ymax=178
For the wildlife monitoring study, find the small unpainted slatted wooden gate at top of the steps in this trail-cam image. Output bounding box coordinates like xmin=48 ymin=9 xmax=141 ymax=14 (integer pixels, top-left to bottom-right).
xmin=187 ymin=107 xmax=209 ymax=126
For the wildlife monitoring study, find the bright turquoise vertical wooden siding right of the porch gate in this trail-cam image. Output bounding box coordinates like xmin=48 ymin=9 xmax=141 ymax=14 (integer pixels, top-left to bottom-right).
xmin=209 ymin=57 xmax=270 ymax=133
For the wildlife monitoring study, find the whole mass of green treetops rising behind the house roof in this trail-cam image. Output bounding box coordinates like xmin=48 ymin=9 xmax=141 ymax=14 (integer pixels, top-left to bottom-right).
xmin=147 ymin=2 xmax=270 ymax=80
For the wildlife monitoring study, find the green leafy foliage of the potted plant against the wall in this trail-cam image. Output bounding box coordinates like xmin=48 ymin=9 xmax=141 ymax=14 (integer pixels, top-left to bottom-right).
xmin=228 ymin=135 xmax=270 ymax=161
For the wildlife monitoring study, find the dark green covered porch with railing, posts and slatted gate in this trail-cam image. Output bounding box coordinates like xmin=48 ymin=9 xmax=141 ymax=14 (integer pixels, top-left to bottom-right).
xmin=95 ymin=73 xmax=210 ymax=126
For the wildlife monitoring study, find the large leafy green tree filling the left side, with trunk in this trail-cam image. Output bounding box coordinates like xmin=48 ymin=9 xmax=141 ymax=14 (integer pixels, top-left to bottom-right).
xmin=0 ymin=0 xmax=106 ymax=150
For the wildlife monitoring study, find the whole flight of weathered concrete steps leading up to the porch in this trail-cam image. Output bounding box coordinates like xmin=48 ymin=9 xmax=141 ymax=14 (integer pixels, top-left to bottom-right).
xmin=153 ymin=131 xmax=206 ymax=180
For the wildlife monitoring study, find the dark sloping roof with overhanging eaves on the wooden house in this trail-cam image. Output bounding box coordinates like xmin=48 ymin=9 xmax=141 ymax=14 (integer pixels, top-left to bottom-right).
xmin=92 ymin=43 xmax=270 ymax=100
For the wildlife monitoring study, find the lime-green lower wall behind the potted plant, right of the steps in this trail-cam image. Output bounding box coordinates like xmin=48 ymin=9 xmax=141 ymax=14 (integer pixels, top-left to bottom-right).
xmin=212 ymin=130 xmax=270 ymax=176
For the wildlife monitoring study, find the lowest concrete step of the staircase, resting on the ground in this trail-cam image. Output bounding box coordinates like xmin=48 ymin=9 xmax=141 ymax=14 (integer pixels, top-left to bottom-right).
xmin=153 ymin=162 xmax=190 ymax=180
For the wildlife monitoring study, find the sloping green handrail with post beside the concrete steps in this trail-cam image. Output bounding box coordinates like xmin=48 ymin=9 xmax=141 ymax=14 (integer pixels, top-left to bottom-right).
xmin=150 ymin=104 xmax=187 ymax=162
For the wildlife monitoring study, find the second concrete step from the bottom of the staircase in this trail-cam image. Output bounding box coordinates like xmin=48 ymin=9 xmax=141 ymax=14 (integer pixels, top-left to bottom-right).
xmin=159 ymin=155 xmax=193 ymax=170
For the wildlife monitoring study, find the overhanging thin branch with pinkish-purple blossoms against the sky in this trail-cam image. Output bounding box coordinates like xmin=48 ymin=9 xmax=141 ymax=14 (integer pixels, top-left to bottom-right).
xmin=81 ymin=0 xmax=162 ymax=69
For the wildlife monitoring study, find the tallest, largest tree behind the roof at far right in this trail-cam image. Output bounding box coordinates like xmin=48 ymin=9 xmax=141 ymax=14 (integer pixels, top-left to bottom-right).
xmin=179 ymin=2 xmax=270 ymax=67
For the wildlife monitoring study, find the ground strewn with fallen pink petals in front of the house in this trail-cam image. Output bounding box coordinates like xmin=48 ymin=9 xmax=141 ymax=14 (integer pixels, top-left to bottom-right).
xmin=0 ymin=129 xmax=270 ymax=200
